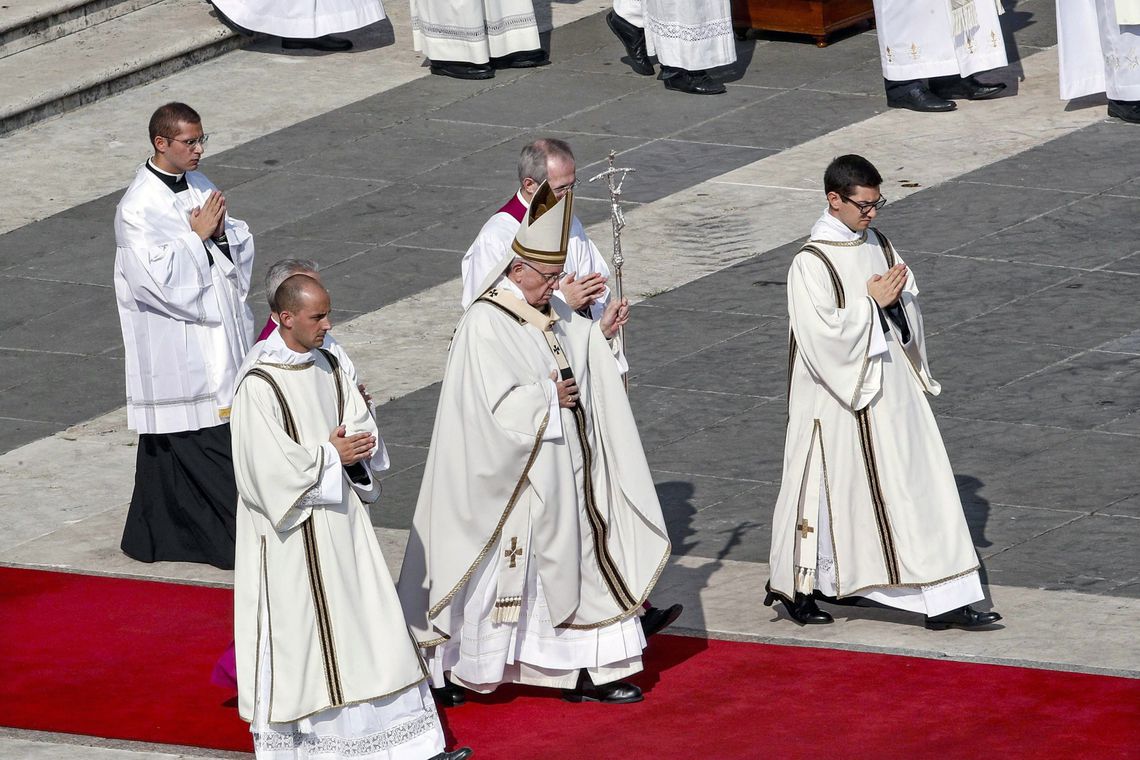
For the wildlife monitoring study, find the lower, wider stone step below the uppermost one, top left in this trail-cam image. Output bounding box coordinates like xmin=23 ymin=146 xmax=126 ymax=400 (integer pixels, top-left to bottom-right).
xmin=0 ymin=0 xmax=247 ymax=134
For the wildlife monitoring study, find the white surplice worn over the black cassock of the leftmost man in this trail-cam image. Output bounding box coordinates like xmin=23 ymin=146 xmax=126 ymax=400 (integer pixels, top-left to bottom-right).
xmin=114 ymin=165 xmax=253 ymax=433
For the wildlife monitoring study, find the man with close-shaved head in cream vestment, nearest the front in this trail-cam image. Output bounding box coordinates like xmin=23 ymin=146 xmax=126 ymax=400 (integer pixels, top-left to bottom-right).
xmin=233 ymin=275 xmax=471 ymax=760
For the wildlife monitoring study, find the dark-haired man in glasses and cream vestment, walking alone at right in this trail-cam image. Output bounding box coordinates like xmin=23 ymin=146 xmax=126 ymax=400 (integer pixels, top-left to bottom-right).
xmin=765 ymin=155 xmax=1001 ymax=629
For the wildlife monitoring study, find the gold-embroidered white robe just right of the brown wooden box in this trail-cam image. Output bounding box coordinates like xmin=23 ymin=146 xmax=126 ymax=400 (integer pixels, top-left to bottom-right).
xmin=874 ymin=0 xmax=1009 ymax=81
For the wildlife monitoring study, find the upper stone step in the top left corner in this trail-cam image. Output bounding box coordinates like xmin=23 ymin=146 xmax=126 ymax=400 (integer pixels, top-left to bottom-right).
xmin=0 ymin=0 xmax=166 ymax=58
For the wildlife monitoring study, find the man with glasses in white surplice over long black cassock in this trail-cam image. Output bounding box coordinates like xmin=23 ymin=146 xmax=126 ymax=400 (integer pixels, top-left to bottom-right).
xmin=114 ymin=103 xmax=253 ymax=570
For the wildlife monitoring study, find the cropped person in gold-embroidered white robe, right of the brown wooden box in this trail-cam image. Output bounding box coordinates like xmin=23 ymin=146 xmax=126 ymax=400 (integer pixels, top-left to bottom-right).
xmin=874 ymin=0 xmax=1008 ymax=113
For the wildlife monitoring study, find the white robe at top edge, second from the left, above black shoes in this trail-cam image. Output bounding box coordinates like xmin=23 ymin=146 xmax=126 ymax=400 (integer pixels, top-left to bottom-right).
xmin=412 ymin=0 xmax=542 ymax=64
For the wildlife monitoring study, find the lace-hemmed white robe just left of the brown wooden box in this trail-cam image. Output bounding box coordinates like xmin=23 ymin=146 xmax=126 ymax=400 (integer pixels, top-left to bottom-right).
xmin=613 ymin=0 xmax=736 ymax=72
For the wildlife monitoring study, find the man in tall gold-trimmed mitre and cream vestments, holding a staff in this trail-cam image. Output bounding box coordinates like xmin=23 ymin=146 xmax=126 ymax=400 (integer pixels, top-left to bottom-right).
xmin=398 ymin=181 xmax=669 ymax=703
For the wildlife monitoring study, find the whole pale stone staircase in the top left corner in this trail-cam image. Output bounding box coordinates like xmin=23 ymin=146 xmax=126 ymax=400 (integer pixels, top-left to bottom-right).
xmin=0 ymin=0 xmax=247 ymax=136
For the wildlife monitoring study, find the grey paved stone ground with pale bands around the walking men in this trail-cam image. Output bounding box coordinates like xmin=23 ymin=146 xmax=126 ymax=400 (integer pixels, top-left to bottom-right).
xmin=0 ymin=0 xmax=1140 ymax=757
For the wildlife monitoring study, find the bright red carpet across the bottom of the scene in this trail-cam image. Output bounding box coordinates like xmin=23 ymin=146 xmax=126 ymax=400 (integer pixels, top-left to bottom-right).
xmin=0 ymin=567 xmax=1140 ymax=760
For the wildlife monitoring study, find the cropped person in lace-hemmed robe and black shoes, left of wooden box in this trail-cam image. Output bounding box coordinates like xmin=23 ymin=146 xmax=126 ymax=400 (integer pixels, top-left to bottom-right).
xmin=605 ymin=0 xmax=736 ymax=95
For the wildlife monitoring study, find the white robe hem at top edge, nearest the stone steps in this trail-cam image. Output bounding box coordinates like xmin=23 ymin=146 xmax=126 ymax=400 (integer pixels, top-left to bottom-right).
xmin=211 ymin=0 xmax=384 ymax=40
